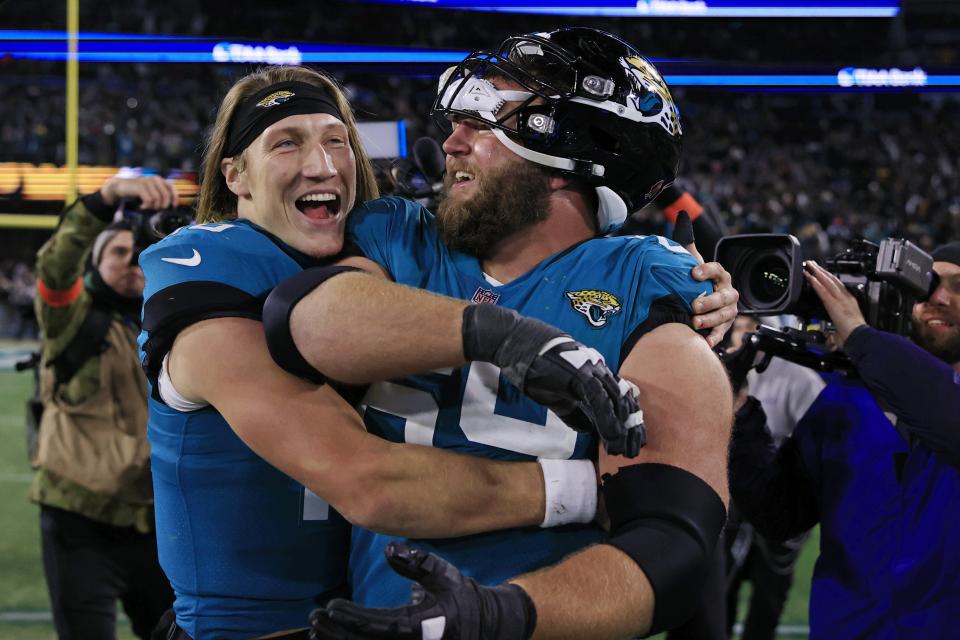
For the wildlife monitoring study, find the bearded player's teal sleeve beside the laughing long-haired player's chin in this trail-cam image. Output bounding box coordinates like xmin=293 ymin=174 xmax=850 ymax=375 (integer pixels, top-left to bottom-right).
xmin=347 ymin=197 xmax=440 ymax=282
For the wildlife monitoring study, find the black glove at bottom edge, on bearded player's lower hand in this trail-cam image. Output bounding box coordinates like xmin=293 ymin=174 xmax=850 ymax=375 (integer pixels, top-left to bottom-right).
xmin=310 ymin=542 xmax=537 ymax=640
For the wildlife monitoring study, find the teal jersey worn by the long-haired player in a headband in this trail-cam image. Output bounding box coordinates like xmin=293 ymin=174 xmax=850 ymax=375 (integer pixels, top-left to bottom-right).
xmin=140 ymin=220 xmax=349 ymax=640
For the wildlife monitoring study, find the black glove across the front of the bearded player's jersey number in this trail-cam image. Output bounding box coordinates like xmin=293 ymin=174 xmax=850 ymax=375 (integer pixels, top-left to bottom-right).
xmin=463 ymin=304 xmax=646 ymax=458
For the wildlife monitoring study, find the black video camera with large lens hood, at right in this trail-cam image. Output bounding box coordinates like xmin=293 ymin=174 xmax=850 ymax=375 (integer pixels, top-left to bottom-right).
xmin=716 ymin=234 xmax=935 ymax=335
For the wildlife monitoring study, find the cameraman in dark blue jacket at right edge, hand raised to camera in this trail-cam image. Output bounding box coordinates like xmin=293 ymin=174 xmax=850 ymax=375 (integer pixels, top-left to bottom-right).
xmin=730 ymin=243 xmax=960 ymax=639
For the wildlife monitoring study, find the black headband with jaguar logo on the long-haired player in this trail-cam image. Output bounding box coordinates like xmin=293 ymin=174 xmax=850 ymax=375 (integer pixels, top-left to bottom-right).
xmin=223 ymin=81 xmax=343 ymax=158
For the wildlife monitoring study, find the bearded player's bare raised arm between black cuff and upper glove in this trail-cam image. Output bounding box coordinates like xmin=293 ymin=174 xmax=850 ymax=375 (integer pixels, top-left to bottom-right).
xmin=290 ymin=273 xmax=467 ymax=384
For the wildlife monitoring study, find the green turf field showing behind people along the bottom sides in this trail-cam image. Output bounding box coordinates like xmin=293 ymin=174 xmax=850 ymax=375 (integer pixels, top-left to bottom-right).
xmin=0 ymin=352 xmax=819 ymax=640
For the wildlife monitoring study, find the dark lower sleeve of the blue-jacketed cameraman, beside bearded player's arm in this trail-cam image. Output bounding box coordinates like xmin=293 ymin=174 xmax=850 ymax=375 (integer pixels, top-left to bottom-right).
xmin=729 ymin=397 xmax=820 ymax=541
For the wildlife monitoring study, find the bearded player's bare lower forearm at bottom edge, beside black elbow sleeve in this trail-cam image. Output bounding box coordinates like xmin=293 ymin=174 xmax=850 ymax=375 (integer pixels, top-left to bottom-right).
xmin=511 ymin=545 xmax=654 ymax=640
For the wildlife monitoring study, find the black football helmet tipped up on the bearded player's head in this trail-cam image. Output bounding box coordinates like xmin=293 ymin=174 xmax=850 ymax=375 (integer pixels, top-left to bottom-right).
xmin=433 ymin=27 xmax=681 ymax=233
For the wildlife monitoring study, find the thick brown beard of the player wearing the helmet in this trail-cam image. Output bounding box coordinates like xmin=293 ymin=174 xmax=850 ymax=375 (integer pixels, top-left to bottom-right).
xmin=437 ymin=162 xmax=550 ymax=260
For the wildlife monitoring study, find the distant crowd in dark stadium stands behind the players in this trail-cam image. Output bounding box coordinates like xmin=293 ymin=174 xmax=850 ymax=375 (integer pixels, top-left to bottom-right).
xmin=0 ymin=0 xmax=960 ymax=255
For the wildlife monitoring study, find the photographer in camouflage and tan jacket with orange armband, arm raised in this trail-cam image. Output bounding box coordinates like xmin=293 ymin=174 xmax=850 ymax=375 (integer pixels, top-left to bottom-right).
xmin=29 ymin=177 xmax=176 ymax=639
